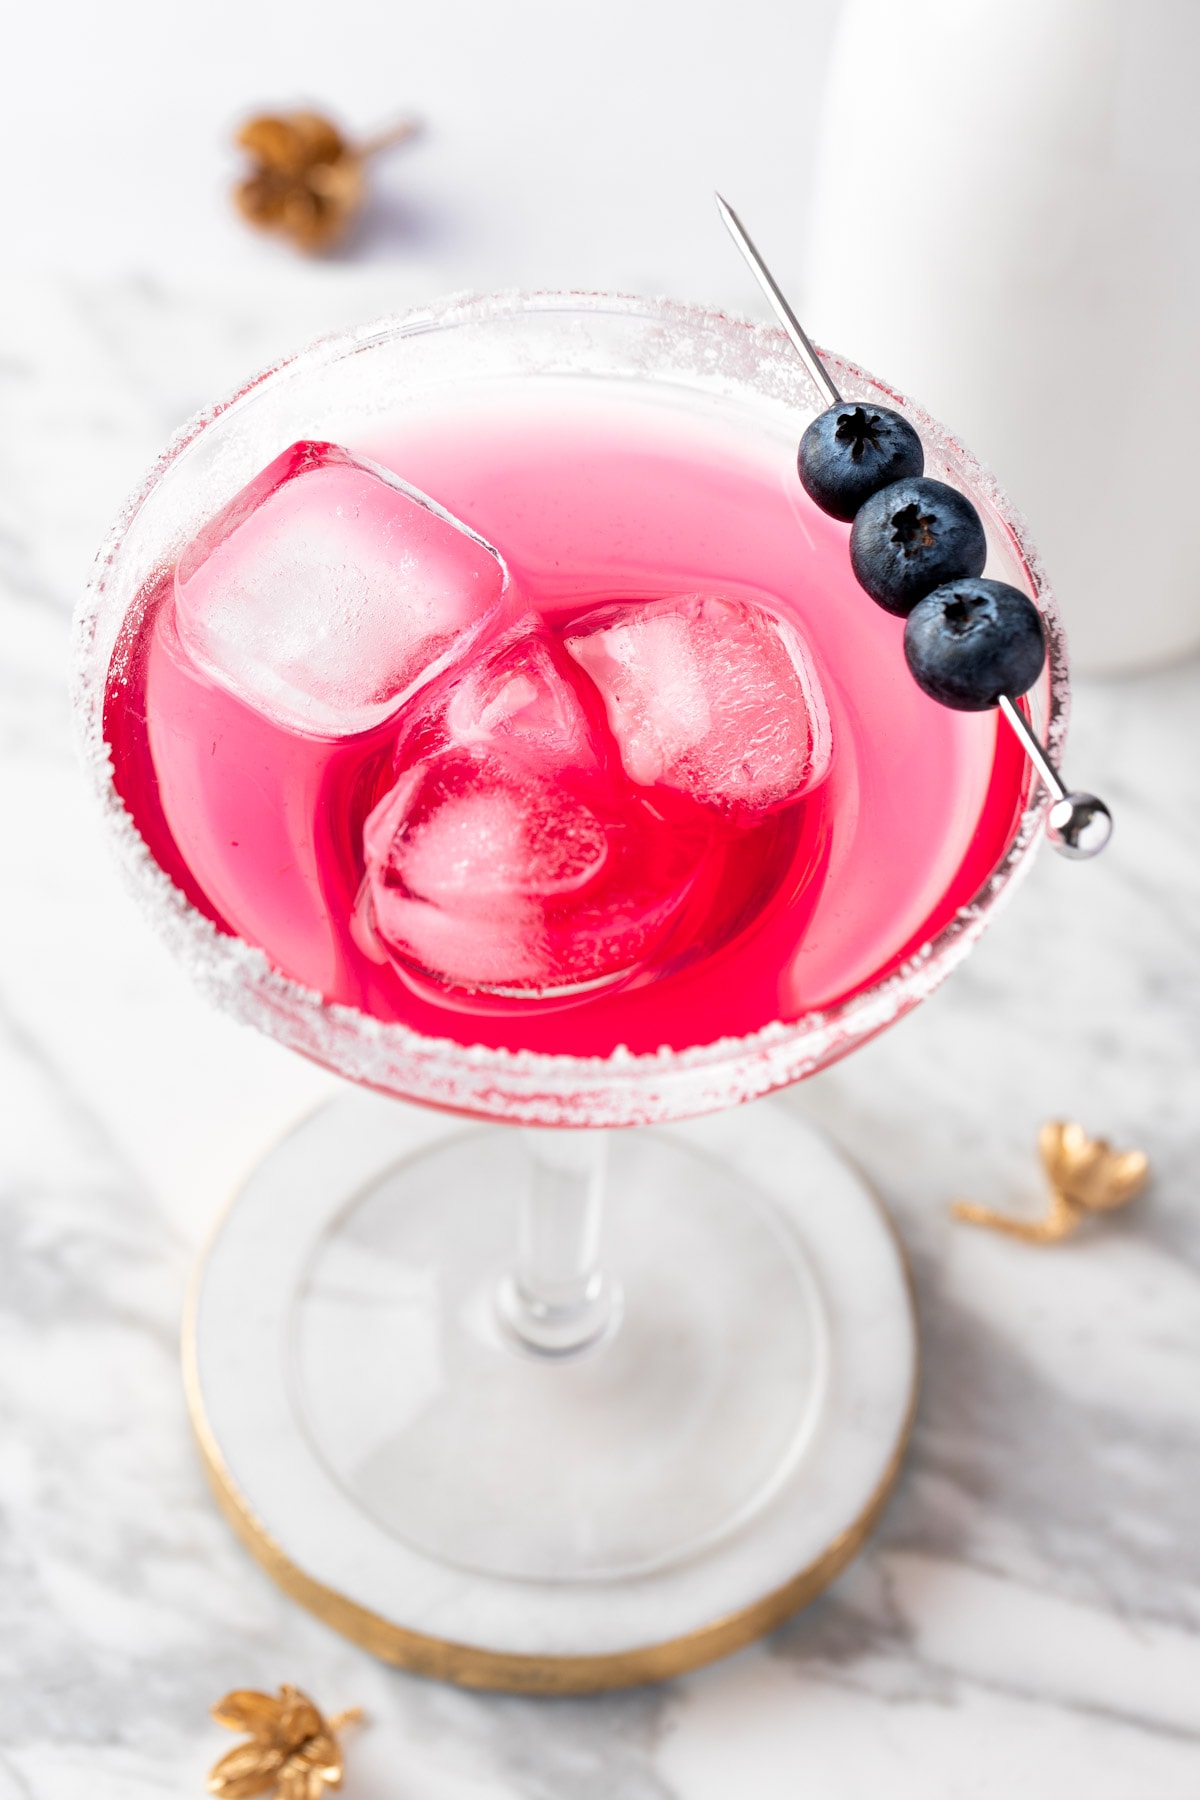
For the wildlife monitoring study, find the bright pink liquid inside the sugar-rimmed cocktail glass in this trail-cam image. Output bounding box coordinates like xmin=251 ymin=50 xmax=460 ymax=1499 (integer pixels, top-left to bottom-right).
xmin=104 ymin=378 xmax=1027 ymax=1055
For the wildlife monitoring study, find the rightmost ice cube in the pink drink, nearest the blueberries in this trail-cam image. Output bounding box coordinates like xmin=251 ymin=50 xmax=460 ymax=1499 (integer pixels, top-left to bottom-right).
xmin=567 ymin=594 xmax=833 ymax=819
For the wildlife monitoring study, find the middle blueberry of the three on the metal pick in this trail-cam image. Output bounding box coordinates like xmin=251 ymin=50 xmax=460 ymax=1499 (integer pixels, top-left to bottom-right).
xmin=849 ymin=477 xmax=988 ymax=617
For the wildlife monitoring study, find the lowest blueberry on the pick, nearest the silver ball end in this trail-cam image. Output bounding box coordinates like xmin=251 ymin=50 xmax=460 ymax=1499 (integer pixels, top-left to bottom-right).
xmin=905 ymin=581 xmax=1045 ymax=713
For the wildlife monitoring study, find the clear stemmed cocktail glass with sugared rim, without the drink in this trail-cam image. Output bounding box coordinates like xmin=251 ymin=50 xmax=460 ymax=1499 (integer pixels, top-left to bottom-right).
xmin=77 ymin=295 xmax=1067 ymax=1648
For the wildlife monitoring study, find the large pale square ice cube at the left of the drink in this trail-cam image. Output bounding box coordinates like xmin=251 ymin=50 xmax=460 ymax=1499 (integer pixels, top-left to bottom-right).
xmin=175 ymin=443 xmax=507 ymax=738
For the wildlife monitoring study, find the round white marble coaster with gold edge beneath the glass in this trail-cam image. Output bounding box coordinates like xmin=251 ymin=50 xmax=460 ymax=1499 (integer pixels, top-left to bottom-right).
xmin=184 ymin=1091 xmax=918 ymax=1694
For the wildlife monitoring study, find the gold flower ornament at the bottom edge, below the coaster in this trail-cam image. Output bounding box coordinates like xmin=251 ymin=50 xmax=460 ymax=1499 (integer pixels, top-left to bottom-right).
xmin=207 ymin=1683 xmax=362 ymax=1800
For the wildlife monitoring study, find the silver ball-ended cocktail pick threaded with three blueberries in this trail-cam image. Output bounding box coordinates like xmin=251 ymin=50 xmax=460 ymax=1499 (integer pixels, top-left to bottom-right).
xmin=716 ymin=194 xmax=1112 ymax=859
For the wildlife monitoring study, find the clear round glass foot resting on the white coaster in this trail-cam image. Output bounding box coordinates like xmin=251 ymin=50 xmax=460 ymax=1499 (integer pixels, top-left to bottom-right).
xmin=291 ymin=1127 xmax=828 ymax=1580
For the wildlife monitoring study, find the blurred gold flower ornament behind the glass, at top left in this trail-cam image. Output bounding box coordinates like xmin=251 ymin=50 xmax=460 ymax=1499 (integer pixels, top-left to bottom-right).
xmin=234 ymin=110 xmax=419 ymax=252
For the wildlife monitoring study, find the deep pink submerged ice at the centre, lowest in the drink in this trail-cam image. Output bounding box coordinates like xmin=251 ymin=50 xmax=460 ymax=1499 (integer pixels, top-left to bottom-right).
xmin=354 ymin=626 xmax=705 ymax=995
